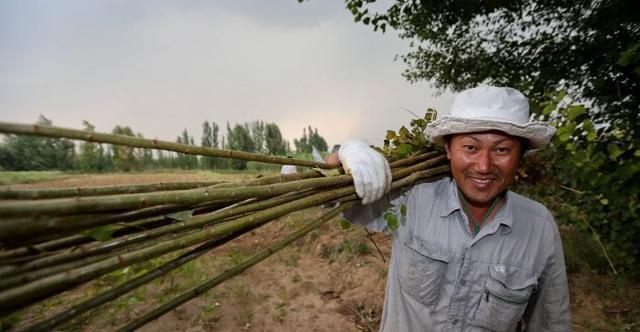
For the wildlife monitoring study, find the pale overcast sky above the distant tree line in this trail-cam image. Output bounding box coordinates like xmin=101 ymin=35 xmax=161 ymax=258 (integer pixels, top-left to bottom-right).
xmin=0 ymin=0 xmax=451 ymax=145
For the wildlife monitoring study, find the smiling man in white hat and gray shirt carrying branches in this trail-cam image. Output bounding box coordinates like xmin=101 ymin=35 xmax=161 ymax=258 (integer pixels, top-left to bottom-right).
xmin=338 ymin=86 xmax=571 ymax=332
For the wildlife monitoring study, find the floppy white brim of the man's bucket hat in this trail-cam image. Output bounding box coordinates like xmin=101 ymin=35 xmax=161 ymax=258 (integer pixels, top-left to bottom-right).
xmin=425 ymin=117 xmax=556 ymax=150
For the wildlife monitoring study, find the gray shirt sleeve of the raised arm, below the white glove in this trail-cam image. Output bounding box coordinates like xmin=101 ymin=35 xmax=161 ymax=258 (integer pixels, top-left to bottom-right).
xmin=344 ymin=190 xmax=404 ymax=233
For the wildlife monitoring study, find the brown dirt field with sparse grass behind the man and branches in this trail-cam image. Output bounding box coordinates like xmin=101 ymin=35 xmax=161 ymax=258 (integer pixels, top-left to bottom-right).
xmin=0 ymin=172 xmax=640 ymax=331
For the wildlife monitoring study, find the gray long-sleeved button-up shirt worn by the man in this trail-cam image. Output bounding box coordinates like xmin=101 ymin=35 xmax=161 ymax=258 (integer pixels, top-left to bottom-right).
xmin=345 ymin=178 xmax=571 ymax=332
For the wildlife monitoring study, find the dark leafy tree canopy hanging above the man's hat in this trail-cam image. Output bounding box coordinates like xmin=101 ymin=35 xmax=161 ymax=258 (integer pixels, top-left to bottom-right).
xmin=345 ymin=0 xmax=640 ymax=130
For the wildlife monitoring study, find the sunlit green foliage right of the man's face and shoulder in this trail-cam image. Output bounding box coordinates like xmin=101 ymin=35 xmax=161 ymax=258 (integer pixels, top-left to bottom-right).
xmin=524 ymin=93 xmax=640 ymax=278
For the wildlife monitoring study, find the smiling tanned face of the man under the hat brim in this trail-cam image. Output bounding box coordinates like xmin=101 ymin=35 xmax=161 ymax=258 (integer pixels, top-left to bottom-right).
xmin=445 ymin=131 xmax=522 ymax=206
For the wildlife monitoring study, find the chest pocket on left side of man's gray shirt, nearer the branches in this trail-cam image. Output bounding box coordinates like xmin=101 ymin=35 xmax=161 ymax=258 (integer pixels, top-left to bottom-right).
xmin=398 ymin=238 xmax=451 ymax=308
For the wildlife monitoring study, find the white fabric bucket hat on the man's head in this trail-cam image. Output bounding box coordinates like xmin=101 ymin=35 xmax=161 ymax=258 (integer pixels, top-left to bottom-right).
xmin=425 ymin=85 xmax=556 ymax=150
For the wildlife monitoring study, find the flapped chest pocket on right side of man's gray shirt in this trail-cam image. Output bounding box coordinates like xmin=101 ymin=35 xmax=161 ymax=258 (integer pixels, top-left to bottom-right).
xmin=475 ymin=265 xmax=537 ymax=331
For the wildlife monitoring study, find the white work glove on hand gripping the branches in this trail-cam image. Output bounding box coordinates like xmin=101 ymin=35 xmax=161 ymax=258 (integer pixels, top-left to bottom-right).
xmin=338 ymin=140 xmax=391 ymax=204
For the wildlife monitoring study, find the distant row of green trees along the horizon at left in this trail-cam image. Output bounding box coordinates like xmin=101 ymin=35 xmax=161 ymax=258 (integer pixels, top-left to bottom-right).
xmin=0 ymin=115 xmax=328 ymax=172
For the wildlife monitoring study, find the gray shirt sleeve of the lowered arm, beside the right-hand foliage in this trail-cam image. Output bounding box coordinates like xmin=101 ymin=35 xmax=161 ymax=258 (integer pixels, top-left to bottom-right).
xmin=525 ymin=218 xmax=572 ymax=331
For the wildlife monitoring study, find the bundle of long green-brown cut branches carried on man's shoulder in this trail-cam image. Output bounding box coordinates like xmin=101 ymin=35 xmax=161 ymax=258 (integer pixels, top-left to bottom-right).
xmin=0 ymin=120 xmax=448 ymax=331
